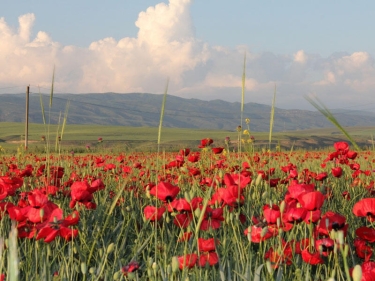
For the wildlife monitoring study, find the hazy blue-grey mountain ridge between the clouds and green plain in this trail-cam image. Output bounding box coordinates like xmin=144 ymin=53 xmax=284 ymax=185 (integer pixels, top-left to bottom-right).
xmin=0 ymin=93 xmax=375 ymax=132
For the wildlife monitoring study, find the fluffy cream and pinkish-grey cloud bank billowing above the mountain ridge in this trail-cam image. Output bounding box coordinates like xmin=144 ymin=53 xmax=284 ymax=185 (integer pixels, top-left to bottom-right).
xmin=0 ymin=0 xmax=375 ymax=108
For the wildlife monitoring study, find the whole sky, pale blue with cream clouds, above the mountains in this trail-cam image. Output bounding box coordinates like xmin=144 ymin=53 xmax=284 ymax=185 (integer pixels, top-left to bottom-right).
xmin=0 ymin=0 xmax=375 ymax=111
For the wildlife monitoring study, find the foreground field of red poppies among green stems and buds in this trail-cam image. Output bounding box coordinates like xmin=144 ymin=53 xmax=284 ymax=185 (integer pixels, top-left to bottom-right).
xmin=0 ymin=138 xmax=375 ymax=281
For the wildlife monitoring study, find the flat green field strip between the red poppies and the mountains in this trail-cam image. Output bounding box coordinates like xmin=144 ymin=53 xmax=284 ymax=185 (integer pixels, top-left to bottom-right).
xmin=0 ymin=123 xmax=375 ymax=152
